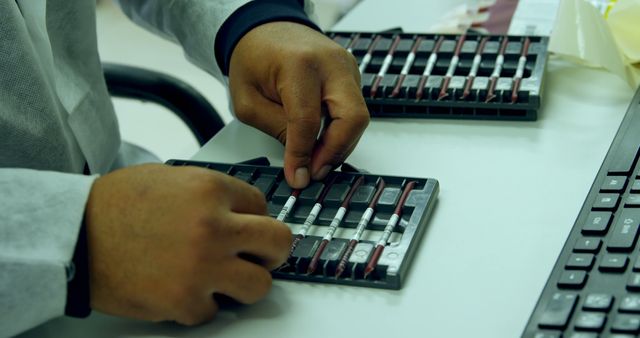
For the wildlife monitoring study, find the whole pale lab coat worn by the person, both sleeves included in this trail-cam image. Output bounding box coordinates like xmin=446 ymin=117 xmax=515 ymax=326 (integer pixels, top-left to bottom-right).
xmin=0 ymin=0 xmax=248 ymax=336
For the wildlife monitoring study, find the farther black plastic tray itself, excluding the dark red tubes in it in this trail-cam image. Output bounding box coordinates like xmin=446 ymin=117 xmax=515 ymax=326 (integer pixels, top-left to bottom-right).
xmin=327 ymin=32 xmax=549 ymax=121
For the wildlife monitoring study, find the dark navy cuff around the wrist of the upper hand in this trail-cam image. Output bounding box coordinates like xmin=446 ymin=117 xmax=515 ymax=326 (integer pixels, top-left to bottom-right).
xmin=215 ymin=0 xmax=322 ymax=75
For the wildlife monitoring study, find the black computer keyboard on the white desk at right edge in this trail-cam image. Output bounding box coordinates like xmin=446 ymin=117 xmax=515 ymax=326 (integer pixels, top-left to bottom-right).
xmin=523 ymin=89 xmax=640 ymax=338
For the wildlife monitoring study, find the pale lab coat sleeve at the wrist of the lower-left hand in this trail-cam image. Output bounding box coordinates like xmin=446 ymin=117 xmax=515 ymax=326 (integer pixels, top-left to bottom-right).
xmin=0 ymin=168 xmax=96 ymax=336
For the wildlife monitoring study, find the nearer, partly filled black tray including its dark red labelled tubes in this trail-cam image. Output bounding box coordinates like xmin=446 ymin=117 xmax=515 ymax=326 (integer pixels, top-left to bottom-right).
xmin=168 ymin=160 xmax=438 ymax=289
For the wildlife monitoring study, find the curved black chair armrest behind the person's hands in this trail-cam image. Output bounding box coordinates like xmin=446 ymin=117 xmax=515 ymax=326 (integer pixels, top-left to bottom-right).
xmin=102 ymin=63 xmax=224 ymax=146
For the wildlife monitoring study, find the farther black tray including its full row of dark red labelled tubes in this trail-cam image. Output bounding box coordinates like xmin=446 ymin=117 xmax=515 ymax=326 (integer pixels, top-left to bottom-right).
xmin=329 ymin=32 xmax=548 ymax=120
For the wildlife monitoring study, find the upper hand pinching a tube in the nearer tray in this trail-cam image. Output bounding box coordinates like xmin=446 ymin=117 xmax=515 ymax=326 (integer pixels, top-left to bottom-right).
xmin=229 ymin=22 xmax=369 ymax=188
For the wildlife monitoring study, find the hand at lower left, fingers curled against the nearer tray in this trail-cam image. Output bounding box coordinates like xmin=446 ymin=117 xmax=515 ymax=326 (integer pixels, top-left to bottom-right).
xmin=85 ymin=164 xmax=291 ymax=325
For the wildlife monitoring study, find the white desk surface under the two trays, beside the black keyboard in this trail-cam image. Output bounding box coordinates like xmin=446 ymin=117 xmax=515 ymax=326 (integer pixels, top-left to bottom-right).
xmin=17 ymin=0 xmax=633 ymax=338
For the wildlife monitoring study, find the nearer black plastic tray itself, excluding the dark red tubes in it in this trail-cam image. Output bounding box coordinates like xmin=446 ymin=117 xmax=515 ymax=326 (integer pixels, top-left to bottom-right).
xmin=167 ymin=160 xmax=439 ymax=290
